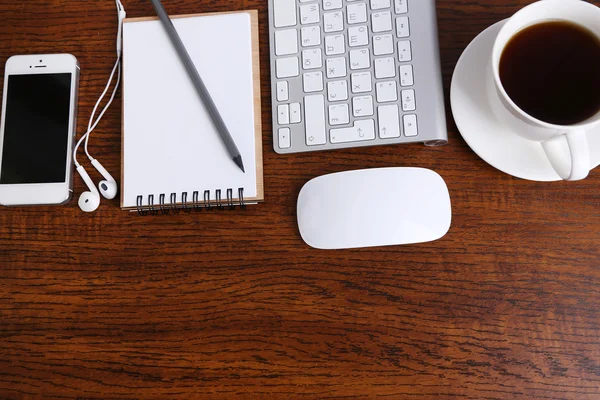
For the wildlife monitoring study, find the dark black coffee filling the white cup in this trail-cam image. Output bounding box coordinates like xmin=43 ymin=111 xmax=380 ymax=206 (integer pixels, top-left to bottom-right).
xmin=500 ymin=21 xmax=600 ymax=125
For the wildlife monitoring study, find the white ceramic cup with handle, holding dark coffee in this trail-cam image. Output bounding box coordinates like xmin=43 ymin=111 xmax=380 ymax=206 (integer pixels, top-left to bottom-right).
xmin=487 ymin=0 xmax=600 ymax=181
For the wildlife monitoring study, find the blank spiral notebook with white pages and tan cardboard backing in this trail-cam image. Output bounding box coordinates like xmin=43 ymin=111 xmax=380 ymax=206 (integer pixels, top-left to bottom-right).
xmin=121 ymin=11 xmax=264 ymax=214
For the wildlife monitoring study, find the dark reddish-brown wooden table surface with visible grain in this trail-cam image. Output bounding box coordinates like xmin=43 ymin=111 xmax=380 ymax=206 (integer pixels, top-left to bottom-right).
xmin=0 ymin=0 xmax=600 ymax=399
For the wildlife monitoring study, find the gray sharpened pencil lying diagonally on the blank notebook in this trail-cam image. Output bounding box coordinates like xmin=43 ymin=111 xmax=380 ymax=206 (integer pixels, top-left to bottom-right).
xmin=151 ymin=0 xmax=246 ymax=172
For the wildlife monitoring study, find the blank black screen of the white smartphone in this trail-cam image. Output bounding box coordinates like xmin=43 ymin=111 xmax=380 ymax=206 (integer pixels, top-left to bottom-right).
xmin=0 ymin=73 xmax=72 ymax=184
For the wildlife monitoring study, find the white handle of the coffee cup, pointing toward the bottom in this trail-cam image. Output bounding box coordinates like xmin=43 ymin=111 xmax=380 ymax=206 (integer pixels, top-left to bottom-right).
xmin=542 ymin=129 xmax=590 ymax=181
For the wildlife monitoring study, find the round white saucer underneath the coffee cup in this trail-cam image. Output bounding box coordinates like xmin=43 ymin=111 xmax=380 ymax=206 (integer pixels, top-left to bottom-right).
xmin=450 ymin=20 xmax=600 ymax=182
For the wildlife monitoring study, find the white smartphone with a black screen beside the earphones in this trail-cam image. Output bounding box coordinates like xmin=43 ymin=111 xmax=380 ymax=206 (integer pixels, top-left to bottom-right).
xmin=0 ymin=54 xmax=79 ymax=206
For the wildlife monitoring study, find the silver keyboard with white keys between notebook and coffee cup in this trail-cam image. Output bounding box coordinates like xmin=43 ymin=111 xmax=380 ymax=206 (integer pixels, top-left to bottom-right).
xmin=269 ymin=0 xmax=448 ymax=154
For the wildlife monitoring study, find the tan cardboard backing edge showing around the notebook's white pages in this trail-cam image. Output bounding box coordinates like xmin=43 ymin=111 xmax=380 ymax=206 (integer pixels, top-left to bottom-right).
xmin=120 ymin=10 xmax=265 ymax=211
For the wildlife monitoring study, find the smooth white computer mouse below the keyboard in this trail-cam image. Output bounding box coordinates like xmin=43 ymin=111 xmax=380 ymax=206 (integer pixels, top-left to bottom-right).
xmin=297 ymin=168 xmax=452 ymax=249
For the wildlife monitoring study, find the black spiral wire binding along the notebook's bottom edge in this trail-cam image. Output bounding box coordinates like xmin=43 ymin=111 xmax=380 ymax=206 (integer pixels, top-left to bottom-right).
xmin=136 ymin=188 xmax=246 ymax=216
